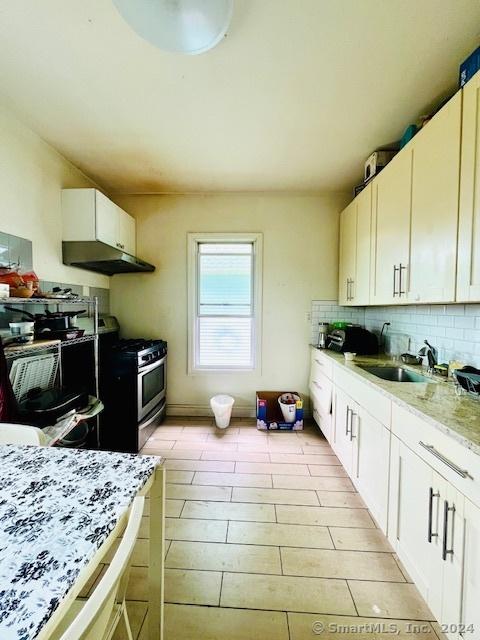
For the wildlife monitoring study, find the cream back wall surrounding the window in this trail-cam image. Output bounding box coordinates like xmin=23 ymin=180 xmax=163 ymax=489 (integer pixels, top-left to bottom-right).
xmin=111 ymin=194 xmax=348 ymax=415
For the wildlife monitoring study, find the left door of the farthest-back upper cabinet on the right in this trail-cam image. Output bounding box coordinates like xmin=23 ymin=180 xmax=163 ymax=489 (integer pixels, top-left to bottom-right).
xmin=338 ymin=200 xmax=357 ymax=305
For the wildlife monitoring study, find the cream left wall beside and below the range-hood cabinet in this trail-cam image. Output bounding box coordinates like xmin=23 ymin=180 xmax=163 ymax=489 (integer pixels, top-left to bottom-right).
xmin=0 ymin=104 xmax=109 ymax=288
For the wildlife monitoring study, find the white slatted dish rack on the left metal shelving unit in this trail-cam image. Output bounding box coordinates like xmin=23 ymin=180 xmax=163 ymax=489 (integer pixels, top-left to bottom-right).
xmin=9 ymin=353 xmax=59 ymax=402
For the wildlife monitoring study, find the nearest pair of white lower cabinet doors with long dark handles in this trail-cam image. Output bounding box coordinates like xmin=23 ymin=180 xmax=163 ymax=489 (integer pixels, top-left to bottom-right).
xmin=389 ymin=435 xmax=480 ymax=640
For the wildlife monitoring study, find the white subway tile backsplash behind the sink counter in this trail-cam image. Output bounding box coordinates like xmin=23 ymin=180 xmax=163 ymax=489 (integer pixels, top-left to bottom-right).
xmin=312 ymin=300 xmax=480 ymax=367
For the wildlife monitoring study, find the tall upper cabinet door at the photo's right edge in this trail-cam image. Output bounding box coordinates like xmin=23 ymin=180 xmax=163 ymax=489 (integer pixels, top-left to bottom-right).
xmin=457 ymin=72 xmax=480 ymax=302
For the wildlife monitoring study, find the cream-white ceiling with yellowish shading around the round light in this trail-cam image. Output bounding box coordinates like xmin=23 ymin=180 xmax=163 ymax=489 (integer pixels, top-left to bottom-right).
xmin=0 ymin=0 xmax=480 ymax=193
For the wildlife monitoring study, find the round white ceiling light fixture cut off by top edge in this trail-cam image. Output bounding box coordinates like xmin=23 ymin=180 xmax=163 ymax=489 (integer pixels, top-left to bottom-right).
xmin=113 ymin=0 xmax=233 ymax=55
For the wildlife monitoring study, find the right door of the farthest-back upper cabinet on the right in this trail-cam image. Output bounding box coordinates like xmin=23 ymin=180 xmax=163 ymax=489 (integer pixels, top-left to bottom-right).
xmin=353 ymin=183 xmax=372 ymax=305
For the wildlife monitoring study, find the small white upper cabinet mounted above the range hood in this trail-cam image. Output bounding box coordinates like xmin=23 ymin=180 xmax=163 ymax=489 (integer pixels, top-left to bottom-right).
xmin=62 ymin=189 xmax=136 ymax=255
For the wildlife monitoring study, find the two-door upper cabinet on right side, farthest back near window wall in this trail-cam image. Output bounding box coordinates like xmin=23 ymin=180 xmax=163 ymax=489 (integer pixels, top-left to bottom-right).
xmin=338 ymin=184 xmax=372 ymax=305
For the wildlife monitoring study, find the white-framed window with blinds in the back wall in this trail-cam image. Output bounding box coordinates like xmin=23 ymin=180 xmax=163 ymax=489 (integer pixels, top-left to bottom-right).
xmin=189 ymin=234 xmax=262 ymax=372
